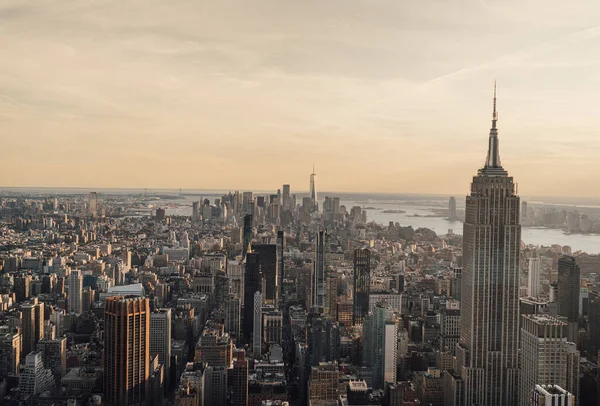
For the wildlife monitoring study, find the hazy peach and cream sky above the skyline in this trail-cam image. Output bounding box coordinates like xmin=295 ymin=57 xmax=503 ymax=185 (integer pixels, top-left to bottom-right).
xmin=0 ymin=0 xmax=600 ymax=197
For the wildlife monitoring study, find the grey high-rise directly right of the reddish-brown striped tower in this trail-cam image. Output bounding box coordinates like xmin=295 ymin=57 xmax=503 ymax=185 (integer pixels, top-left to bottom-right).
xmin=150 ymin=308 xmax=172 ymax=388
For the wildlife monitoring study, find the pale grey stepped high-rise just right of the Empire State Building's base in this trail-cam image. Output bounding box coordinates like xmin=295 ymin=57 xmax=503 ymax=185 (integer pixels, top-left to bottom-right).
xmin=519 ymin=314 xmax=579 ymax=406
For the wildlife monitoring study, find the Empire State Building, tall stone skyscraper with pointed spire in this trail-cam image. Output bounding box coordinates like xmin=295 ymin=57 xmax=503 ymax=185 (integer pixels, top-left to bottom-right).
xmin=456 ymin=85 xmax=521 ymax=406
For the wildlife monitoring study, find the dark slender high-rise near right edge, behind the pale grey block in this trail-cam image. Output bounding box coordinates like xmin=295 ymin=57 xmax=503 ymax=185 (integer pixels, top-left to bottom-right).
xmin=558 ymin=255 xmax=581 ymax=344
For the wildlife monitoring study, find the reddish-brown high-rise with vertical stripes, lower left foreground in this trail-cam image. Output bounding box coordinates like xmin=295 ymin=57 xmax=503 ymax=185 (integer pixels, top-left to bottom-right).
xmin=102 ymin=296 xmax=151 ymax=406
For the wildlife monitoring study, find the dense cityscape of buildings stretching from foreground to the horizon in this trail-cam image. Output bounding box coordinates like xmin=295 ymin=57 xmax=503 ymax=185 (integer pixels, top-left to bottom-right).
xmin=0 ymin=89 xmax=600 ymax=406
